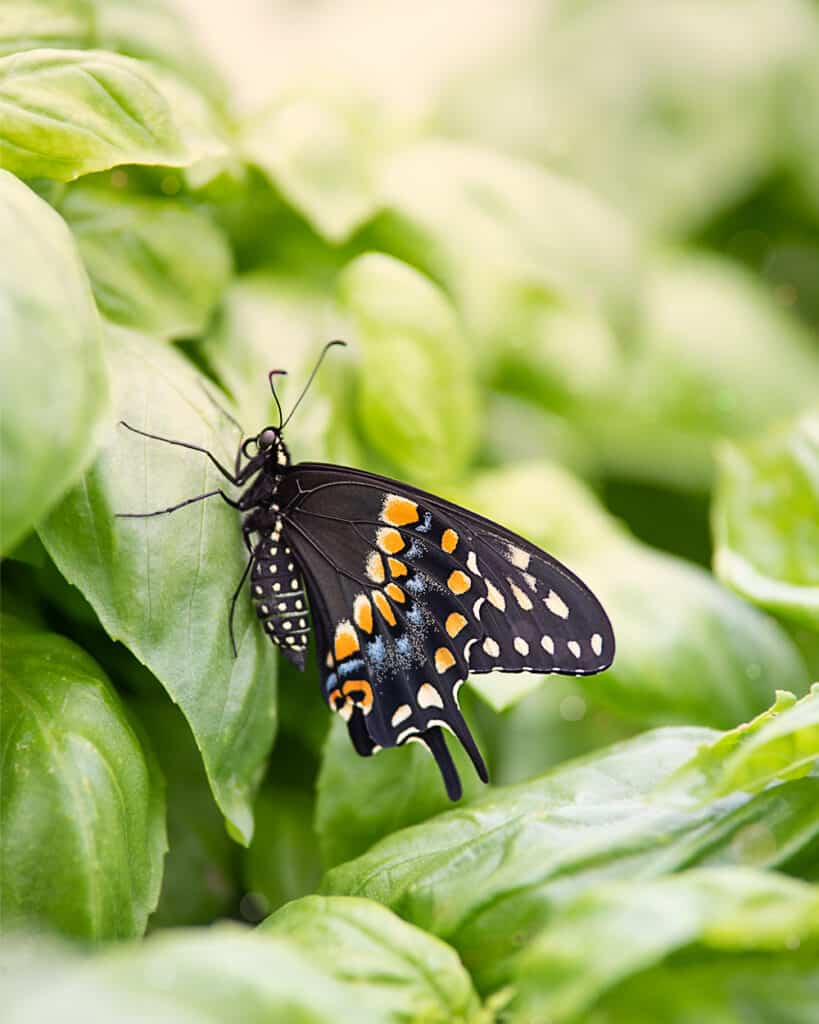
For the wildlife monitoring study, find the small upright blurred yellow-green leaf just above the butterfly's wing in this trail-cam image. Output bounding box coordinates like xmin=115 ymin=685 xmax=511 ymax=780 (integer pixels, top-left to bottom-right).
xmin=339 ymin=253 xmax=478 ymax=481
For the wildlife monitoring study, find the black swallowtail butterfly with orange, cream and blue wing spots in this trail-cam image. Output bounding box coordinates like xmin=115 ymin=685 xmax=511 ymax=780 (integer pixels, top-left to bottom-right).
xmin=116 ymin=341 xmax=614 ymax=801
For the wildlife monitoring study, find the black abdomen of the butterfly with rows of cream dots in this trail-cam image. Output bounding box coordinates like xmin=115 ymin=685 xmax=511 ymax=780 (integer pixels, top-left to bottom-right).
xmin=251 ymin=519 xmax=310 ymax=669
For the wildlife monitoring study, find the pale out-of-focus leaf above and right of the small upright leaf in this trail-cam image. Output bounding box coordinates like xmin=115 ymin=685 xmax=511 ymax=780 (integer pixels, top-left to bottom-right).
xmin=373 ymin=141 xmax=637 ymax=362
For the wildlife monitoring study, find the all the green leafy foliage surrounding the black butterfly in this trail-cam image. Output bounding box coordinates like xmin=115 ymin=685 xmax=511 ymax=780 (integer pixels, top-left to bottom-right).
xmin=0 ymin=0 xmax=819 ymax=1024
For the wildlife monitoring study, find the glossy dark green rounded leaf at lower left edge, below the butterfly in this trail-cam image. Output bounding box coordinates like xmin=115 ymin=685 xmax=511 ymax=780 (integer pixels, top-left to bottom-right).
xmin=0 ymin=616 xmax=167 ymax=939
